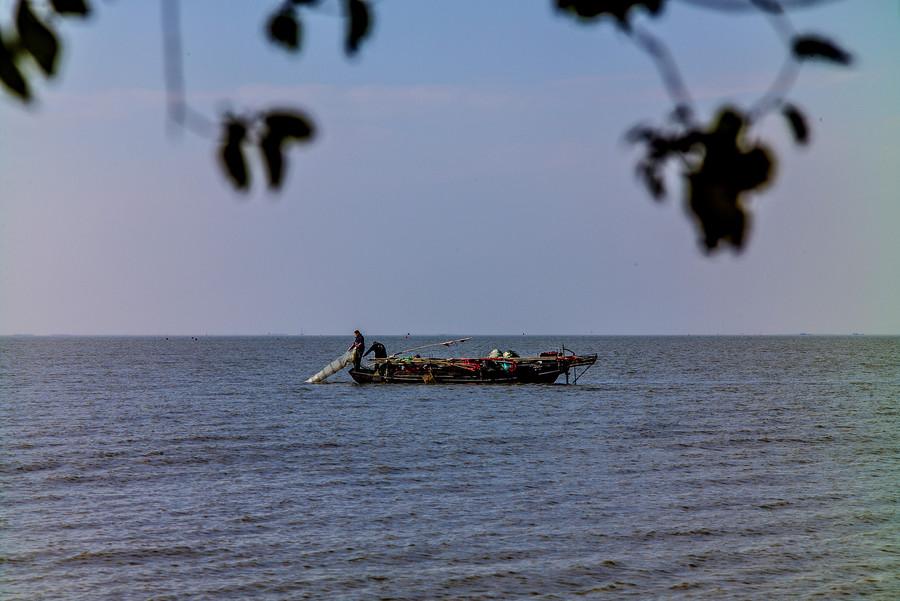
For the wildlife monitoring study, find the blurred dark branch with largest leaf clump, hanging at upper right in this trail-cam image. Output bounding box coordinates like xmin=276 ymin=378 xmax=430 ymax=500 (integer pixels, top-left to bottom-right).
xmin=556 ymin=0 xmax=851 ymax=252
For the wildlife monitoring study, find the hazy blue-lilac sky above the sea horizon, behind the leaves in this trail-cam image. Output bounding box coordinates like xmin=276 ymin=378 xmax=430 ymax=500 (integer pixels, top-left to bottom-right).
xmin=0 ymin=0 xmax=900 ymax=334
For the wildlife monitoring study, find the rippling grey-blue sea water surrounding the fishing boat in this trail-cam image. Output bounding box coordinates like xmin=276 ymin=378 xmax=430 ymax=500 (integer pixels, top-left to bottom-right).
xmin=0 ymin=336 xmax=900 ymax=601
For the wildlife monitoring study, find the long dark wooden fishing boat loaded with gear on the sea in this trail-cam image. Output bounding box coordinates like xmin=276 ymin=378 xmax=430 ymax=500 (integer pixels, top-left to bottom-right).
xmin=350 ymin=338 xmax=597 ymax=384
